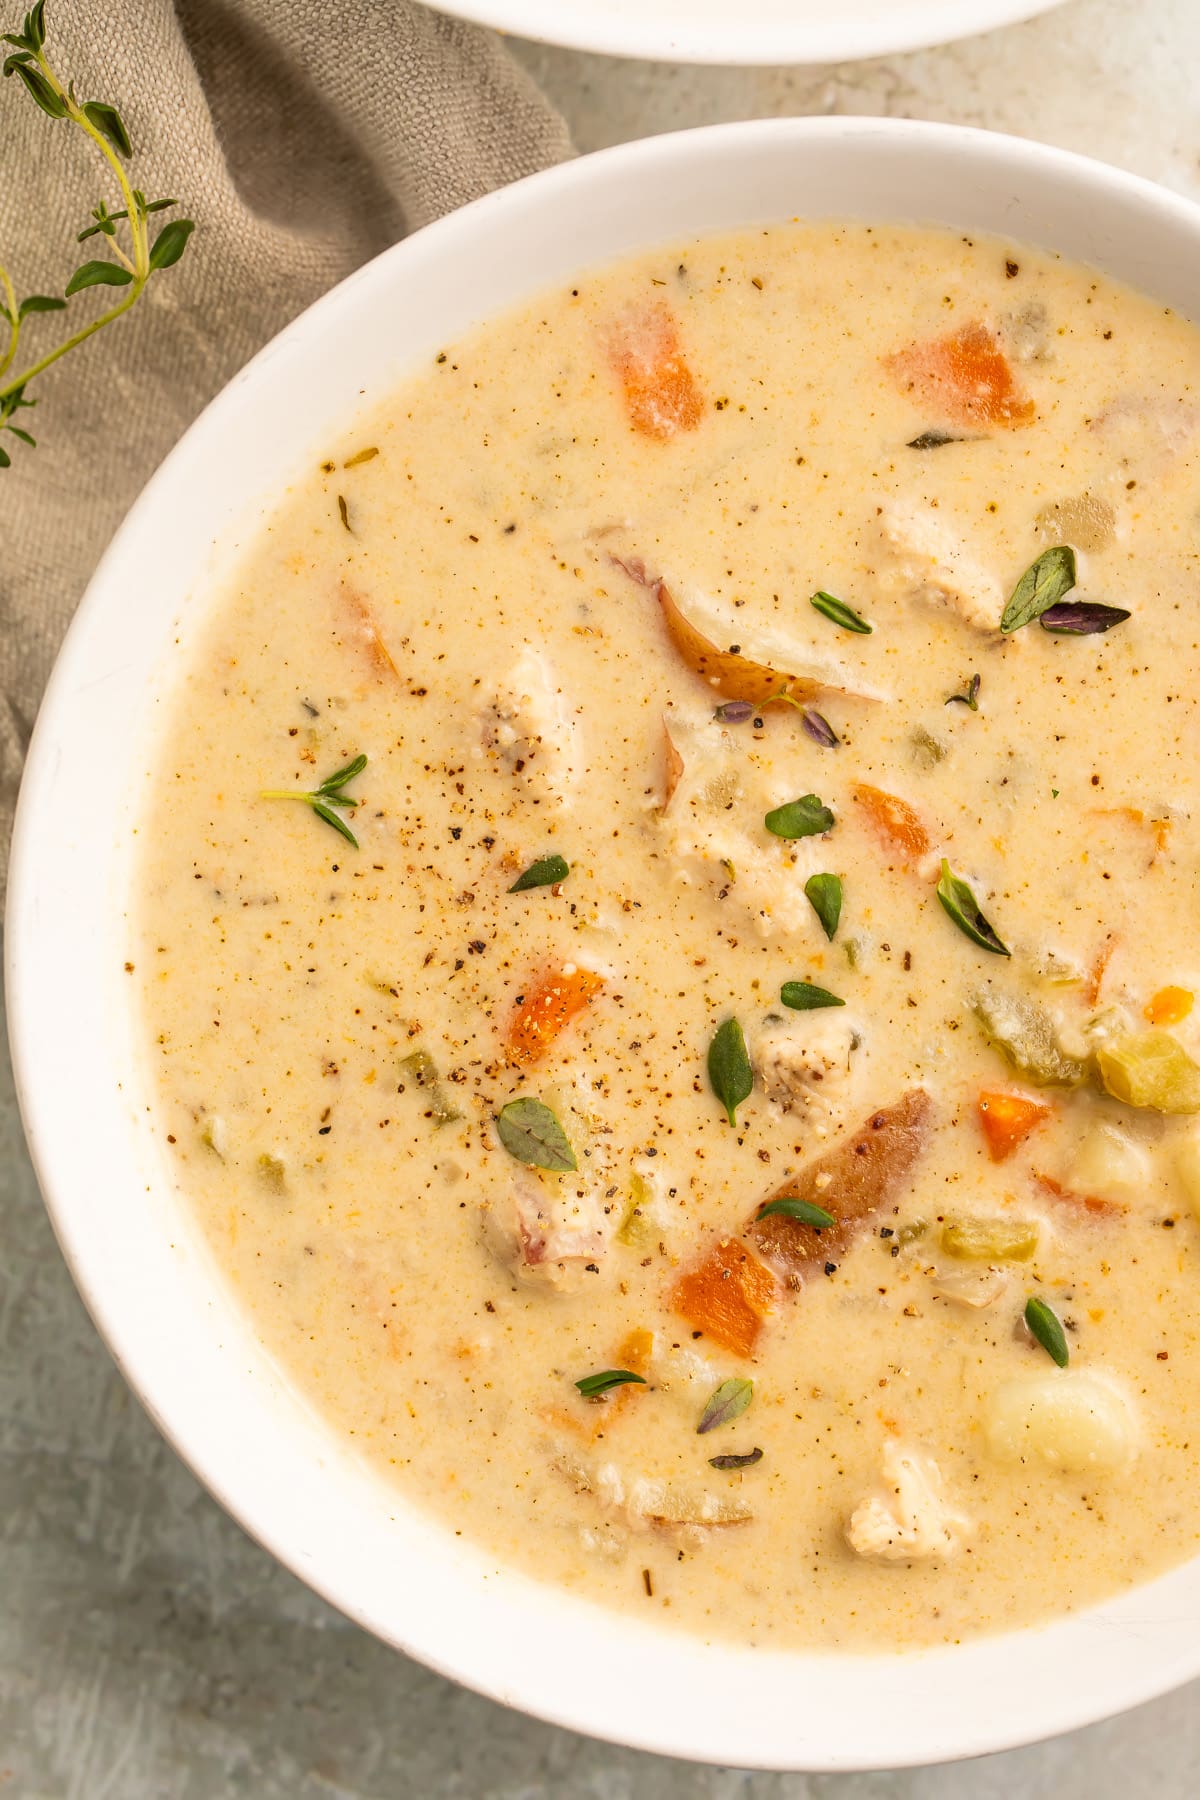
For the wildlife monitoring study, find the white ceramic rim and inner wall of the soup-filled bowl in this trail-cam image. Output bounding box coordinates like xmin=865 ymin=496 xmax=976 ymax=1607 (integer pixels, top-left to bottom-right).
xmin=7 ymin=119 xmax=1200 ymax=1769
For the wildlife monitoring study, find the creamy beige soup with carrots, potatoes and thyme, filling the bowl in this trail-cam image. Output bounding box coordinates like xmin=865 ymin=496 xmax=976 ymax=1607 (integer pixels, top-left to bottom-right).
xmin=130 ymin=225 xmax=1200 ymax=1649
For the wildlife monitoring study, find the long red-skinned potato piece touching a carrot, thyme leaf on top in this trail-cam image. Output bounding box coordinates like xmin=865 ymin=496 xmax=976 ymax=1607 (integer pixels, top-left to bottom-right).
xmin=745 ymin=1087 xmax=934 ymax=1287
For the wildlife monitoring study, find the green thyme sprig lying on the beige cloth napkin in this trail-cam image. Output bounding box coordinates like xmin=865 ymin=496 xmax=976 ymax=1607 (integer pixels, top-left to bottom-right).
xmin=0 ymin=0 xmax=193 ymax=468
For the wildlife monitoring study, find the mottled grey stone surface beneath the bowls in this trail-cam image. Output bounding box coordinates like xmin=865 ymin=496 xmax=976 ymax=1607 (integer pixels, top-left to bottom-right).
xmin=0 ymin=0 xmax=1200 ymax=1800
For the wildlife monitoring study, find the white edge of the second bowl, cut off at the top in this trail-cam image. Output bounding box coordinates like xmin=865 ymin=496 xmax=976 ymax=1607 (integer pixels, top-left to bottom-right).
xmin=435 ymin=0 xmax=1063 ymax=68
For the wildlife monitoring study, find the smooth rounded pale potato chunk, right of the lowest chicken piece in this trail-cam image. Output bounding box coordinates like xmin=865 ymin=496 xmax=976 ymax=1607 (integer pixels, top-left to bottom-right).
xmin=984 ymin=1370 xmax=1137 ymax=1474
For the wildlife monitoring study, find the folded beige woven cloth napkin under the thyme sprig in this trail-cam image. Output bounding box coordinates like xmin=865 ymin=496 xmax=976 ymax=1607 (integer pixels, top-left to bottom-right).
xmin=0 ymin=0 xmax=570 ymax=880
